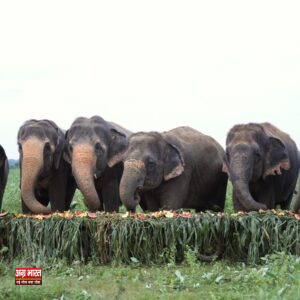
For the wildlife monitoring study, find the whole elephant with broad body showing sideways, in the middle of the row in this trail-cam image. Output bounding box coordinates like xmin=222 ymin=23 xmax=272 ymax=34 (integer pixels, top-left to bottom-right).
xmin=111 ymin=127 xmax=227 ymax=211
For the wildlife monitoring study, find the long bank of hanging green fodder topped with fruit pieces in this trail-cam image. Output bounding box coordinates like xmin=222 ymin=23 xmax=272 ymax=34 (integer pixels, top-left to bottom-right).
xmin=0 ymin=212 xmax=300 ymax=265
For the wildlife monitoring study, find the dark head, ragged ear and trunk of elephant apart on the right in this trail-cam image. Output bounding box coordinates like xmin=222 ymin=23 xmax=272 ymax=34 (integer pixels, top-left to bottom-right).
xmin=223 ymin=123 xmax=289 ymax=211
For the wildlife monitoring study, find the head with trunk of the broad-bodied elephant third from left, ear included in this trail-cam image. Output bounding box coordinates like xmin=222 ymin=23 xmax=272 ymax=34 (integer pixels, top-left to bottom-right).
xmin=110 ymin=132 xmax=185 ymax=210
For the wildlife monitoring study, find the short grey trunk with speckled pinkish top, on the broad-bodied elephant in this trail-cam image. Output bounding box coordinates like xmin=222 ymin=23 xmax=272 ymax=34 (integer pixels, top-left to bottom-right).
xmin=120 ymin=159 xmax=146 ymax=210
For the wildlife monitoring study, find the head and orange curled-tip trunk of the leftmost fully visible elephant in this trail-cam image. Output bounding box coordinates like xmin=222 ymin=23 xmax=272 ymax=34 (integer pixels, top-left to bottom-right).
xmin=18 ymin=120 xmax=64 ymax=213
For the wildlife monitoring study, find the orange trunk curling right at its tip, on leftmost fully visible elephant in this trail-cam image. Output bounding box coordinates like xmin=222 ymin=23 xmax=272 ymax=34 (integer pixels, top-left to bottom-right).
xmin=21 ymin=139 xmax=51 ymax=214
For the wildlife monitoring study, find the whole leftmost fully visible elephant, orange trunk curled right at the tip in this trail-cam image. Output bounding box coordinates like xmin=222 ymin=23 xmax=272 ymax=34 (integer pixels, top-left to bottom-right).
xmin=18 ymin=119 xmax=76 ymax=214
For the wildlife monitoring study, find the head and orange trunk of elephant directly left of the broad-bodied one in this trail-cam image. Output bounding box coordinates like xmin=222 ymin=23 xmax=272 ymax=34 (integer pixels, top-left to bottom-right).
xmin=64 ymin=116 xmax=128 ymax=210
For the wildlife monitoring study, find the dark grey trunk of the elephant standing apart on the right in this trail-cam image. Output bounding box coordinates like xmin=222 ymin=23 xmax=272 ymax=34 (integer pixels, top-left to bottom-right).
xmin=230 ymin=160 xmax=267 ymax=211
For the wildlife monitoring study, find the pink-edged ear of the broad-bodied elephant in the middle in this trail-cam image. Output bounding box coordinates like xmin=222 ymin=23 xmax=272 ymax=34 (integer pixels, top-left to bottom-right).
xmin=164 ymin=136 xmax=185 ymax=181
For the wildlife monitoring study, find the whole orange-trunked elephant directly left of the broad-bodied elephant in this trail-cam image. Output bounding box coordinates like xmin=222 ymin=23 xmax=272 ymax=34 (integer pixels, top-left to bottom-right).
xmin=64 ymin=116 xmax=131 ymax=212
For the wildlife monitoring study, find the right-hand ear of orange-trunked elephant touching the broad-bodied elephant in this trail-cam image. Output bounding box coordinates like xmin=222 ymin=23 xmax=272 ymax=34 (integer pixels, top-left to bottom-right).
xmin=107 ymin=128 xmax=128 ymax=168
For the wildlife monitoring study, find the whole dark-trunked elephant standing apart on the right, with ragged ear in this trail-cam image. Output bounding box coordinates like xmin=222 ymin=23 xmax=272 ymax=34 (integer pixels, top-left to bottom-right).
xmin=223 ymin=123 xmax=299 ymax=211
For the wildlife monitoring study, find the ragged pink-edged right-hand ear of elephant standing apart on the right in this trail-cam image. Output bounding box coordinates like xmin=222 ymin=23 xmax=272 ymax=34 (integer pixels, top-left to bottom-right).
xmin=264 ymin=136 xmax=290 ymax=178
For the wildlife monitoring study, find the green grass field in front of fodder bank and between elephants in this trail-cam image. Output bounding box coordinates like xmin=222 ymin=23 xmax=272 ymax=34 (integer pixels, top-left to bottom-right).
xmin=0 ymin=169 xmax=300 ymax=299
